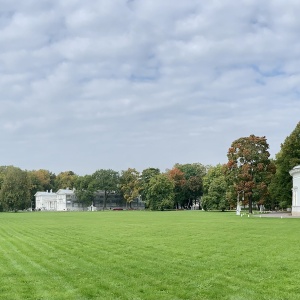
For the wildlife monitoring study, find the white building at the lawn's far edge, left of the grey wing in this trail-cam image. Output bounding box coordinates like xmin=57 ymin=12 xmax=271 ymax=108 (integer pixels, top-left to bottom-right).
xmin=35 ymin=189 xmax=82 ymax=211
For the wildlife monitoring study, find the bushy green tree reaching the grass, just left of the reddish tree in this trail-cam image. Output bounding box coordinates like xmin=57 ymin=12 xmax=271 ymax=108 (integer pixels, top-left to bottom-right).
xmin=146 ymin=174 xmax=174 ymax=210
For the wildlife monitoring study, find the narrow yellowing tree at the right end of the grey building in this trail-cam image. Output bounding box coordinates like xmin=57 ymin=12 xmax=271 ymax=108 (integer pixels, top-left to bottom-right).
xmin=120 ymin=168 xmax=140 ymax=208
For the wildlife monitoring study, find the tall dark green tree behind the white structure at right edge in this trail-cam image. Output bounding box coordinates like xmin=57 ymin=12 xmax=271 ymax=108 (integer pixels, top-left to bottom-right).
xmin=270 ymin=122 xmax=300 ymax=209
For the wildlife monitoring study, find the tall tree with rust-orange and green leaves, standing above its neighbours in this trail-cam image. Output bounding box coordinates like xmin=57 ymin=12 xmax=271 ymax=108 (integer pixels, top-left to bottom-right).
xmin=227 ymin=135 xmax=275 ymax=213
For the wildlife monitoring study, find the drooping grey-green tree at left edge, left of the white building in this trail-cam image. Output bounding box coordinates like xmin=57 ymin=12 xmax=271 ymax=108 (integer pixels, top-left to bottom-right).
xmin=0 ymin=167 xmax=31 ymax=211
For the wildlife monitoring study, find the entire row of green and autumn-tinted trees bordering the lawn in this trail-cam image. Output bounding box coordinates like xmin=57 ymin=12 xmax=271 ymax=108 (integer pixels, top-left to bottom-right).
xmin=0 ymin=122 xmax=300 ymax=213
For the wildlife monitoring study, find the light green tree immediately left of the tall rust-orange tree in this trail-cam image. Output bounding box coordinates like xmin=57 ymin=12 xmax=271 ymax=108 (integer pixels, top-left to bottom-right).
xmin=201 ymin=164 xmax=230 ymax=211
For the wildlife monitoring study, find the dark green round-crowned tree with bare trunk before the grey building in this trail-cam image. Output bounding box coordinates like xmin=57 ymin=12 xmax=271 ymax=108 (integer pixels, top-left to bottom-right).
xmin=92 ymin=169 xmax=119 ymax=209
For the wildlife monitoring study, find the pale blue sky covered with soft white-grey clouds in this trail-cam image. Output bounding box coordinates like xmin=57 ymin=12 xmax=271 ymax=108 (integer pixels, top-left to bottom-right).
xmin=0 ymin=0 xmax=300 ymax=175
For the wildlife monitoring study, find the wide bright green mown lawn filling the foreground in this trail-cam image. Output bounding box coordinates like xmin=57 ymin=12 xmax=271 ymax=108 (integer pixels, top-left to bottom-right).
xmin=0 ymin=211 xmax=300 ymax=300
